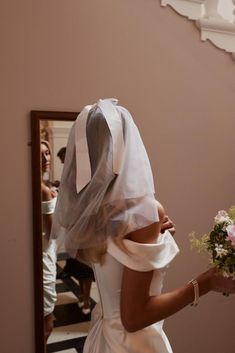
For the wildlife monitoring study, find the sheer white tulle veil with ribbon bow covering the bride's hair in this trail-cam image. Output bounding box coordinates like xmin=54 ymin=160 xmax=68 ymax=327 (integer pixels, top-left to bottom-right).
xmin=51 ymin=99 xmax=159 ymax=257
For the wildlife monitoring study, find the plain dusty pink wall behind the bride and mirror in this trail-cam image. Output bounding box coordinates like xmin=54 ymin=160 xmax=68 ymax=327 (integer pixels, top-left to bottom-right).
xmin=0 ymin=0 xmax=235 ymax=353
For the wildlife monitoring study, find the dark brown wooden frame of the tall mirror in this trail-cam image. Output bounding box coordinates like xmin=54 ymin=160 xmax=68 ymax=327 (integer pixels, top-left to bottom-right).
xmin=30 ymin=110 xmax=78 ymax=353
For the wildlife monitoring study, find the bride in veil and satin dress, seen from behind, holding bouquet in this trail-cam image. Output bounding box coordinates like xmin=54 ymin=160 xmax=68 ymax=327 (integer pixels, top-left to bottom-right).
xmin=52 ymin=99 xmax=235 ymax=353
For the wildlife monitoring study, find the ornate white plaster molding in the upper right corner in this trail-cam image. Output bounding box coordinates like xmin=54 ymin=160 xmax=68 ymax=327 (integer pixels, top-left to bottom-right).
xmin=161 ymin=0 xmax=235 ymax=60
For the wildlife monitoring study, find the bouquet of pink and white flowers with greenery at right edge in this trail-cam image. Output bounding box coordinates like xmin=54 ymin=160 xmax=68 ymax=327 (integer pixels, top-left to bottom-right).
xmin=189 ymin=206 xmax=235 ymax=278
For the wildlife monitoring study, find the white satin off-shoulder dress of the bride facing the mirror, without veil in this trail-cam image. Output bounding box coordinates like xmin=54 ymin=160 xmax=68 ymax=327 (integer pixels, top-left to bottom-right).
xmin=83 ymin=231 xmax=179 ymax=353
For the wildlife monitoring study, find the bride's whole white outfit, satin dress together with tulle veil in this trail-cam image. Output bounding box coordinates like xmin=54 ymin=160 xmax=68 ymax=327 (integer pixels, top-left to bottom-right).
xmin=51 ymin=99 xmax=178 ymax=353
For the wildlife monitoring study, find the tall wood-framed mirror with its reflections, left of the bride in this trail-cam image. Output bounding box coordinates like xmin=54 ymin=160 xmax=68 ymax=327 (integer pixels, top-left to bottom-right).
xmin=31 ymin=111 xmax=98 ymax=353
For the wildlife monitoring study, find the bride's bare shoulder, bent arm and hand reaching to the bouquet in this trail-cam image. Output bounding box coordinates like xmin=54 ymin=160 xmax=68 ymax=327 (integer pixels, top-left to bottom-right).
xmin=121 ymin=222 xmax=235 ymax=332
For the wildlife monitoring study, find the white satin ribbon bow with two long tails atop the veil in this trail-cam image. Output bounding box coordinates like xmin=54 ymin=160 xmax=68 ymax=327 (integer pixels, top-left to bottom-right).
xmin=75 ymin=99 xmax=124 ymax=193
